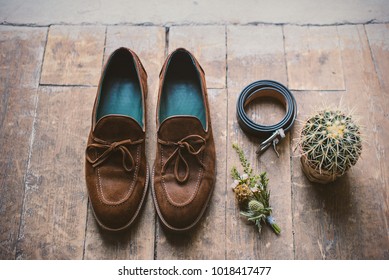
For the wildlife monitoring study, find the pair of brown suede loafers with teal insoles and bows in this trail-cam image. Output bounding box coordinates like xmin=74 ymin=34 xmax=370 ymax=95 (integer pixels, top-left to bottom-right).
xmin=85 ymin=48 xmax=215 ymax=231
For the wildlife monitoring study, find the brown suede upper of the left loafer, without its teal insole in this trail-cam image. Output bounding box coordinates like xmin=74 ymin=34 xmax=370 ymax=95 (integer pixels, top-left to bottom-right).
xmin=85 ymin=48 xmax=149 ymax=231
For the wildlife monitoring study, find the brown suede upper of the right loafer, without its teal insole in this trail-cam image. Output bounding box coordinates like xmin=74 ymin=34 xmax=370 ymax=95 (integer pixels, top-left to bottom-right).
xmin=152 ymin=49 xmax=216 ymax=231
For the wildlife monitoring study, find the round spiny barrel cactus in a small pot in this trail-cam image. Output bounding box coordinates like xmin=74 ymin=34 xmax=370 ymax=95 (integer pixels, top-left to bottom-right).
xmin=300 ymin=110 xmax=362 ymax=184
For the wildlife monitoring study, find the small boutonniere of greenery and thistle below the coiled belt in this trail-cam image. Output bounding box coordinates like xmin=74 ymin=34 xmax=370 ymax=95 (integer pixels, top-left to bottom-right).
xmin=231 ymin=144 xmax=281 ymax=234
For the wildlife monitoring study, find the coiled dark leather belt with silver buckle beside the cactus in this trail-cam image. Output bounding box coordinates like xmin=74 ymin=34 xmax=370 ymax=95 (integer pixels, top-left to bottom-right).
xmin=236 ymin=80 xmax=297 ymax=156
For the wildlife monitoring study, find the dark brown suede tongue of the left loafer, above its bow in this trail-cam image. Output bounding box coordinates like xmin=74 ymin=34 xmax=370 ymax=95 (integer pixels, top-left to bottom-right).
xmin=93 ymin=115 xmax=144 ymax=142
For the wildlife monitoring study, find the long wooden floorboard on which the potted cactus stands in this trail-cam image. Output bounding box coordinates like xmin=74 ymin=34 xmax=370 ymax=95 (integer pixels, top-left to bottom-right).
xmin=292 ymin=91 xmax=361 ymax=259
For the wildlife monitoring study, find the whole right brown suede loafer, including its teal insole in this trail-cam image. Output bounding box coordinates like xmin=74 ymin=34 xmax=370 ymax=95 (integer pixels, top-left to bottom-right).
xmin=152 ymin=49 xmax=215 ymax=231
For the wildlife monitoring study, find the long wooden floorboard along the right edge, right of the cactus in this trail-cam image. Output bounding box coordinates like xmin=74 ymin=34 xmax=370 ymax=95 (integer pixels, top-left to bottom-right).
xmin=338 ymin=25 xmax=389 ymax=259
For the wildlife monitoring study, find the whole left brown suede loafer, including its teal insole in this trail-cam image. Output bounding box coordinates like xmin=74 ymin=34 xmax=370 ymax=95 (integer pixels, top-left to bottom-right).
xmin=85 ymin=48 xmax=149 ymax=231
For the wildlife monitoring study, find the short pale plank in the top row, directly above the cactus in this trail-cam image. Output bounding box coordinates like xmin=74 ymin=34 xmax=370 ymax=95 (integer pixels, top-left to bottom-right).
xmin=284 ymin=25 xmax=345 ymax=90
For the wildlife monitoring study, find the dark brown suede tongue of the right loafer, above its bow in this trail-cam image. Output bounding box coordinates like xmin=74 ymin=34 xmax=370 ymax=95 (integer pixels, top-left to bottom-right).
xmin=158 ymin=116 xmax=206 ymax=142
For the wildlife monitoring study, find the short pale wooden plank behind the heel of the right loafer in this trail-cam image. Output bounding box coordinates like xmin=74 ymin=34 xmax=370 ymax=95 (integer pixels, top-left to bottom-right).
xmin=168 ymin=26 xmax=226 ymax=88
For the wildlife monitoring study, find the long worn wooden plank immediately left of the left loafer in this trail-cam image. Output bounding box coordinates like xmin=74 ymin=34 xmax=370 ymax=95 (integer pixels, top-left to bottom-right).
xmin=17 ymin=87 xmax=96 ymax=259
